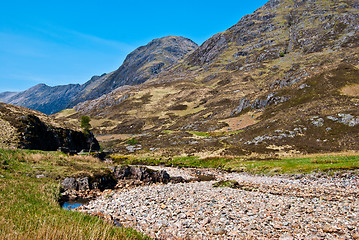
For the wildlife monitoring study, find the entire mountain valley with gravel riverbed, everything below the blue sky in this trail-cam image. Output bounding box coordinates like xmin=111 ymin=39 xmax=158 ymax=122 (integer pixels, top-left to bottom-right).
xmin=0 ymin=0 xmax=359 ymax=240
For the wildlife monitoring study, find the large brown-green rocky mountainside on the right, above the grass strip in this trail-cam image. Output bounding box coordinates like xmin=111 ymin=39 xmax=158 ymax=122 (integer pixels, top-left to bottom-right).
xmin=56 ymin=0 xmax=359 ymax=156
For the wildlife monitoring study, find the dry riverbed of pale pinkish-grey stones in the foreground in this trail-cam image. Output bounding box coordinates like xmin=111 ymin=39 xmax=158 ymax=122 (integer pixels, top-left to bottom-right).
xmin=78 ymin=167 xmax=359 ymax=239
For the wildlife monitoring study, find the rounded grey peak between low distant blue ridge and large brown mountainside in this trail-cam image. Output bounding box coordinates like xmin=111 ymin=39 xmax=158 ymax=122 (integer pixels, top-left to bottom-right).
xmin=66 ymin=36 xmax=198 ymax=107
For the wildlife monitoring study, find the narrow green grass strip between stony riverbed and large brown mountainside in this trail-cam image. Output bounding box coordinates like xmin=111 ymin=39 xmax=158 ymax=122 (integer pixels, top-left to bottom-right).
xmin=112 ymin=153 xmax=359 ymax=174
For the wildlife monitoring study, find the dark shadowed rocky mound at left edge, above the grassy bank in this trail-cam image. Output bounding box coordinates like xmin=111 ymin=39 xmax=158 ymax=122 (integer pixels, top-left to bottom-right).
xmin=0 ymin=103 xmax=100 ymax=152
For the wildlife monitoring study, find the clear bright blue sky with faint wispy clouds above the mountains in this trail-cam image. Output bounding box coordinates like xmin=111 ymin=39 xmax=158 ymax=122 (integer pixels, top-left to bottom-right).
xmin=0 ymin=0 xmax=267 ymax=92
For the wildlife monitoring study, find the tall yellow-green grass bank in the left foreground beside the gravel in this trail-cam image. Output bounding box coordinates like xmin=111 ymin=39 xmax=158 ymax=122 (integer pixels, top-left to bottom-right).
xmin=0 ymin=150 xmax=146 ymax=239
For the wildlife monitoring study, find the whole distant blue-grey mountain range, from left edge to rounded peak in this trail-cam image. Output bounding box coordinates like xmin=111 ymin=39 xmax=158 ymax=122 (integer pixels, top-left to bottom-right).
xmin=0 ymin=36 xmax=198 ymax=114
